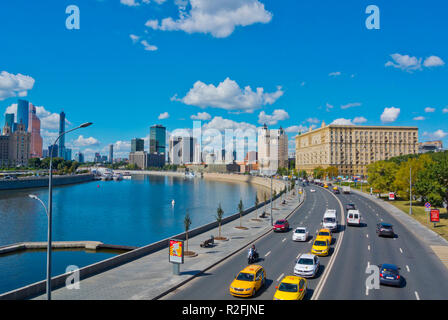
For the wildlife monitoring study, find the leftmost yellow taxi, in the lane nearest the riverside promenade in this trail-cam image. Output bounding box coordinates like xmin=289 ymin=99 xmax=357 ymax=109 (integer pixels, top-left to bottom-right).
xmin=229 ymin=264 xmax=266 ymax=297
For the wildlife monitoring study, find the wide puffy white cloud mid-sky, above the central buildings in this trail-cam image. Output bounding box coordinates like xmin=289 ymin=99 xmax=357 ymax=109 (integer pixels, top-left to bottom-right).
xmin=175 ymin=78 xmax=283 ymax=113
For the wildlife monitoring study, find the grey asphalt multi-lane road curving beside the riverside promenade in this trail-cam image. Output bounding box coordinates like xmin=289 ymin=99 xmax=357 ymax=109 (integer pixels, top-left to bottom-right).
xmin=164 ymin=186 xmax=448 ymax=300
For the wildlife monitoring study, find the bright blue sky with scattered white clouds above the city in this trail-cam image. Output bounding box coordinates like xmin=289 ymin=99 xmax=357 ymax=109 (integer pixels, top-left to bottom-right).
xmin=0 ymin=0 xmax=448 ymax=158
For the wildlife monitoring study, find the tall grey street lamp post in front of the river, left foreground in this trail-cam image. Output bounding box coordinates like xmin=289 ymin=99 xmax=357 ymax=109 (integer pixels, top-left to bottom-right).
xmin=39 ymin=122 xmax=92 ymax=300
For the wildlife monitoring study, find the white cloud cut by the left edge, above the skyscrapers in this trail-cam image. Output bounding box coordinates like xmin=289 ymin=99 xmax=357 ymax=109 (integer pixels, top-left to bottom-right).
xmin=0 ymin=71 xmax=35 ymax=101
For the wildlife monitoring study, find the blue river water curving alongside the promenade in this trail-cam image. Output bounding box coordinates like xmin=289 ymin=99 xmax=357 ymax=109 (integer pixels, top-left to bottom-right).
xmin=0 ymin=175 xmax=268 ymax=293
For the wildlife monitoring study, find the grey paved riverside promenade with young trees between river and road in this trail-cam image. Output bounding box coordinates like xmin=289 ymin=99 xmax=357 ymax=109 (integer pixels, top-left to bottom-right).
xmin=30 ymin=192 xmax=304 ymax=300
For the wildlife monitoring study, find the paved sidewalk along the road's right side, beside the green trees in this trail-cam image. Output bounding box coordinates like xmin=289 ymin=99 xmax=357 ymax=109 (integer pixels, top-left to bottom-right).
xmin=352 ymin=190 xmax=448 ymax=246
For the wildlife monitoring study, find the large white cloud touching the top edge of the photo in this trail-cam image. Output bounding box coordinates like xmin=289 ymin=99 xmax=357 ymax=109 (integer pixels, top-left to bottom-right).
xmin=146 ymin=0 xmax=272 ymax=38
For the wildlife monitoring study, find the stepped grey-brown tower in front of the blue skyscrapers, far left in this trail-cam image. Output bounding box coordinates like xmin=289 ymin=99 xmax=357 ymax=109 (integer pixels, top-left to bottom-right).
xmin=9 ymin=123 xmax=31 ymax=166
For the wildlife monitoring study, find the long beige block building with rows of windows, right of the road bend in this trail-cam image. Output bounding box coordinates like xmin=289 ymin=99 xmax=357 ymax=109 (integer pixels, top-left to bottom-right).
xmin=296 ymin=122 xmax=418 ymax=176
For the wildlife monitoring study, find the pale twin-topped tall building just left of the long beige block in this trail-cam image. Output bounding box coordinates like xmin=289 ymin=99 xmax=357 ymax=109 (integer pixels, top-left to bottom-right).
xmin=258 ymin=124 xmax=288 ymax=173
